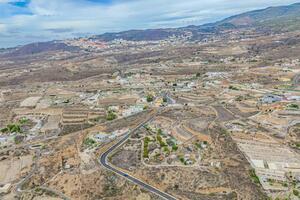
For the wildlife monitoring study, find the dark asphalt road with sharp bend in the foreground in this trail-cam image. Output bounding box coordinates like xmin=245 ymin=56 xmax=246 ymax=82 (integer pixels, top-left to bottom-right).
xmin=99 ymin=112 xmax=176 ymax=200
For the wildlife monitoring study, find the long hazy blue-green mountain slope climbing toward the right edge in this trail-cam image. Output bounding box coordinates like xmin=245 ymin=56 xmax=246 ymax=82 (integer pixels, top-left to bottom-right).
xmin=92 ymin=3 xmax=300 ymax=41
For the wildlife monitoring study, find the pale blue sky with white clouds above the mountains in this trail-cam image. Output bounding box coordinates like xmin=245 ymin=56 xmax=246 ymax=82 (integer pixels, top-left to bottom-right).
xmin=0 ymin=0 xmax=300 ymax=48
